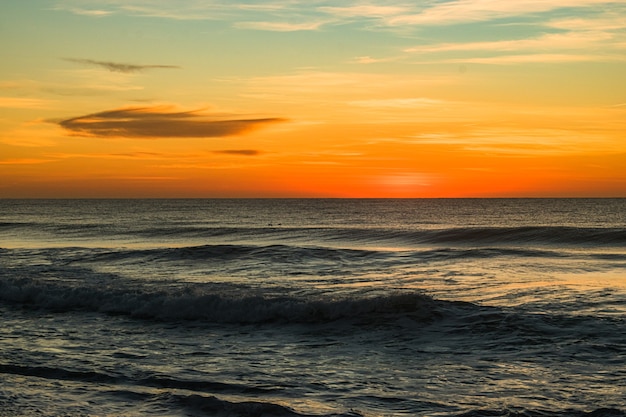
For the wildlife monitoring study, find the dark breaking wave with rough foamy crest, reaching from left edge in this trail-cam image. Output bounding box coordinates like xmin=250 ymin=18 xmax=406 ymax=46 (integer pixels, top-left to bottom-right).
xmin=0 ymin=272 xmax=447 ymax=324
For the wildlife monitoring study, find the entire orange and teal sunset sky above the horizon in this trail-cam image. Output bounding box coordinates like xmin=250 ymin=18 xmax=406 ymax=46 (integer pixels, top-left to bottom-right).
xmin=0 ymin=0 xmax=626 ymax=198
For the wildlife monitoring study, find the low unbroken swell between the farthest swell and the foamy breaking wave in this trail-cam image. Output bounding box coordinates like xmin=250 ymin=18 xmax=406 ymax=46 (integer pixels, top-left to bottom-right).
xmin=6 ymin=242 xmax=626 ymax=278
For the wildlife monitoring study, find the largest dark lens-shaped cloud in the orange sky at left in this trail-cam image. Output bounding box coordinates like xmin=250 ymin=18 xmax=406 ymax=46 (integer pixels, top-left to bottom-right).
xmin=57 ymin=106 xmax=285 ymax=138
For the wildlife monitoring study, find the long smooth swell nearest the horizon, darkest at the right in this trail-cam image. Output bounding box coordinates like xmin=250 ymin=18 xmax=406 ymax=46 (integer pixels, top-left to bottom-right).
xmin=0 ymin=222 xmax=626 ymax=247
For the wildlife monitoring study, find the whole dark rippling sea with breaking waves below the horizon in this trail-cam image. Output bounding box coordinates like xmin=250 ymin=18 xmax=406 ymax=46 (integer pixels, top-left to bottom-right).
xmin=0 ymin=199 xmax=626 ymax=417
